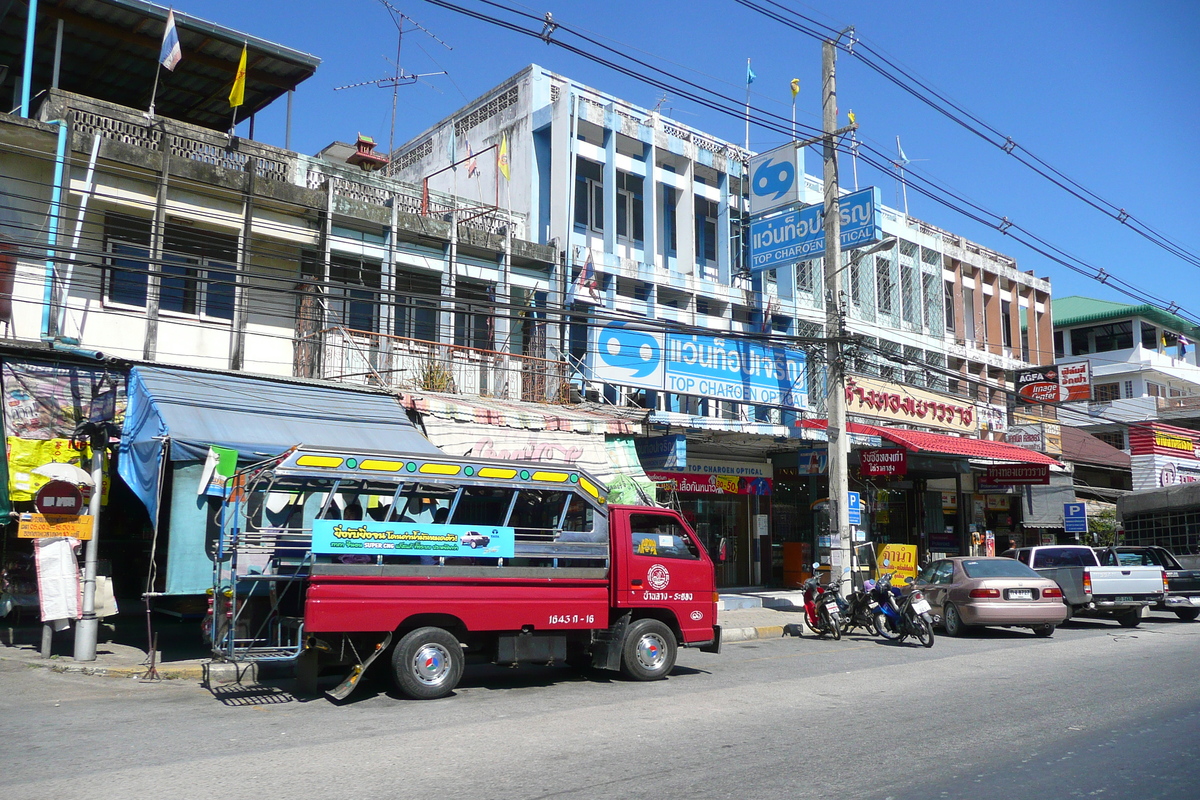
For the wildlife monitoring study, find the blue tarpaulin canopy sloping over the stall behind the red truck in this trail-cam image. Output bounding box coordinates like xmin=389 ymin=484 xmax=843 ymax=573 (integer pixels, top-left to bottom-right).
xmin=118 ymin=366 xmax=442 ymax=519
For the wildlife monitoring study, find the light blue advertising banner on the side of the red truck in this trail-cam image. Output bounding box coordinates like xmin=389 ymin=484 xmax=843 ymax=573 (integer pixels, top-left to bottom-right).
xmin=312 ymin=519 xmax=516 ymax=558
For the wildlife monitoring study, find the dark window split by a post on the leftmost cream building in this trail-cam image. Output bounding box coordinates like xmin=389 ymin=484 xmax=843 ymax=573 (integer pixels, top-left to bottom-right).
xmin=104 ymin=213 xmax=238 ymax=320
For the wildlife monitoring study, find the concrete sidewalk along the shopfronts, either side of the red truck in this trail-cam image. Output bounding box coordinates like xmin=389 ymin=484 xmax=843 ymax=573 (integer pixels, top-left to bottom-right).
xmin=0 ymin=591 xmax=803 ymax=682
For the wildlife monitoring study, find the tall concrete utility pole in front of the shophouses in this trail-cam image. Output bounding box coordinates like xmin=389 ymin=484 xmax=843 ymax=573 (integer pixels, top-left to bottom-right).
xmin=821 ymin=41 xmax=851 ymax=589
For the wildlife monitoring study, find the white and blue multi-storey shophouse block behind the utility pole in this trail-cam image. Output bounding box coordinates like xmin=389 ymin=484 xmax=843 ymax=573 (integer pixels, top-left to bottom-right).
xmin=392 ymin=66 xmax=1061 ymax=584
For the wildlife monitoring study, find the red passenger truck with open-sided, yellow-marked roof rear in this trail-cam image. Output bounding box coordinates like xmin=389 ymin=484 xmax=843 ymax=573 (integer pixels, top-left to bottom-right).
xmin=211 ymin=447 xmax=721 ymax=699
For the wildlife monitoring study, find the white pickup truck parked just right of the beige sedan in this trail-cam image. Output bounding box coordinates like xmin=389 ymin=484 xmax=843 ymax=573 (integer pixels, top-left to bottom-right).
xmin=1003 ymin=545 xmax=1166 ymax=627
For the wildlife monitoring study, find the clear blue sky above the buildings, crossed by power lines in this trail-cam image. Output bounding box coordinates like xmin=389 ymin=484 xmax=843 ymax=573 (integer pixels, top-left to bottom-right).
xmin=176 ymin=0 xmax=1200 ymax=320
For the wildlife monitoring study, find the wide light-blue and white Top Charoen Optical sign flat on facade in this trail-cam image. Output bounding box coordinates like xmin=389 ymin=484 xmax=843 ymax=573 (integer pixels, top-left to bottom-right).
xmin=593 ymin=321 xmax=809 ymax=409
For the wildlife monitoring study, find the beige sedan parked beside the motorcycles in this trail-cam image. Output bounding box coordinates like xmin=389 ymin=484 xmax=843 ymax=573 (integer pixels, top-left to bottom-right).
xmin=913 ymin=557 xmax=1069 ymax=637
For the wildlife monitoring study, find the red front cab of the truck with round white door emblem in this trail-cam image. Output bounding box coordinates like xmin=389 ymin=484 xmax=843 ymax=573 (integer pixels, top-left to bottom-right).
xmin=610 ymin=507 xmax=716 ymax=642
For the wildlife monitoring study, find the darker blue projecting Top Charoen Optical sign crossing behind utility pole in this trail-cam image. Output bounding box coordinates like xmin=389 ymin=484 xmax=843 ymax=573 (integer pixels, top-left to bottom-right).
xmin=750 ymin=186 xmax=883 ymax=272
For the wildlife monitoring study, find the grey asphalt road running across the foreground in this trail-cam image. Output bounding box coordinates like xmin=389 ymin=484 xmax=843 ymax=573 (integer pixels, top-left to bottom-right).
xmin=0 ymin=615 xmax=1200 ymax=800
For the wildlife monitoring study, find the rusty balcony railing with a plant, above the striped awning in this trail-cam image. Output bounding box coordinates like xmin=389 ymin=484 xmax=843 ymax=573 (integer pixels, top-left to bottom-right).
xmin=309 ymin=327 xmax=570 ymax=404
